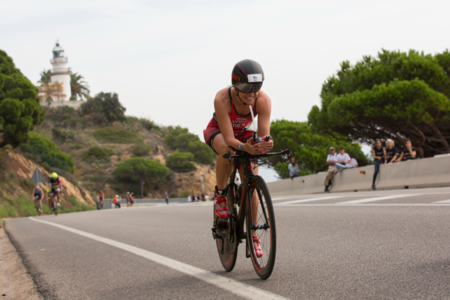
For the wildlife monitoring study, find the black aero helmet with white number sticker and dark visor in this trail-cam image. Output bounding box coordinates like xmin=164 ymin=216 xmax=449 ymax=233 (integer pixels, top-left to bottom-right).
xmin=231 ymin=59 xmax=264 ymax=93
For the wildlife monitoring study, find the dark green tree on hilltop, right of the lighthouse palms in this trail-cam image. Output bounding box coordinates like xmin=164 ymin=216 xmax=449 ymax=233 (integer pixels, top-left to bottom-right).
xmin=81 ymin=92 xmax=126 ymax=122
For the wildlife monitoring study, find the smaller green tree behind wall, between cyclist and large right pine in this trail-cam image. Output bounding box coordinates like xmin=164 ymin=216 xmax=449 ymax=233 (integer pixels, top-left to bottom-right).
xmin=265 ymin=120 xmax=369 ymax=178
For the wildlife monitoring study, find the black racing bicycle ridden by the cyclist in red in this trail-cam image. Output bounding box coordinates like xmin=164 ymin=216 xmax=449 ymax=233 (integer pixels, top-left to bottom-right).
xmin=211 ymin=147 xmax=292 ymax=279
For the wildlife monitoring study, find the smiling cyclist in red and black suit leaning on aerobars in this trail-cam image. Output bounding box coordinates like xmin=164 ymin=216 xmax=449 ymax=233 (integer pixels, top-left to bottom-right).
xmin=203 ymin=59 xmax=273 ymax=257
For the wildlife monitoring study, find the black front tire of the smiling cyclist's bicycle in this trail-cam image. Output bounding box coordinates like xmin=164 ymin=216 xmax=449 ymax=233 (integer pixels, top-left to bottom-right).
xmin=246 ymin=176 xmax=277 ymax=280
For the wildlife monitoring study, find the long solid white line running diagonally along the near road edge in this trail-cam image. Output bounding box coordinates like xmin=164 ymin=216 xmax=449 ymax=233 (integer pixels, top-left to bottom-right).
xmin=29 ymin=217 xmax=288 ymax=300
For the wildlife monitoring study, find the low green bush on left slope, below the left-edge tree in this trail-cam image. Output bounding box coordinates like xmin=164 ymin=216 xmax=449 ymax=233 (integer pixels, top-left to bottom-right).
xmin=20 ymin=132 xmax=74 ymax=173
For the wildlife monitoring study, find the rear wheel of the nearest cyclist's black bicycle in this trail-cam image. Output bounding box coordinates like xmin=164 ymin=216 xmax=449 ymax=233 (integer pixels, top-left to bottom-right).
xmin=213 ymin=185 xmax=239 ymax=272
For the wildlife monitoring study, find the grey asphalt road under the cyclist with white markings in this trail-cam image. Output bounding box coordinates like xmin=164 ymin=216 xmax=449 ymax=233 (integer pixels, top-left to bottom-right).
xmin=6 ymin=188 xmax=450 ymax=299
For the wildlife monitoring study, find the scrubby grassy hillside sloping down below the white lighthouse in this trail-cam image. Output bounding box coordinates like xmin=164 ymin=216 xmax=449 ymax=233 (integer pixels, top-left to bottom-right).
xmin=25 ymin=106 xmax=215 ymax=198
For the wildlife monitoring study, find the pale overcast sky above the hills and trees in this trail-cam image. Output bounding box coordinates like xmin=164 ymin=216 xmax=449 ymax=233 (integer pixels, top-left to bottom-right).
xmin=0 ymin=0 xmax=450 ymax=180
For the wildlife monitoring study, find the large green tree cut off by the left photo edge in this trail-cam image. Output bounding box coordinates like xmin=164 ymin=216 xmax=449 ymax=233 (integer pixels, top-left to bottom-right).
xmin=0 ymin=50 xmax=45 ymax=147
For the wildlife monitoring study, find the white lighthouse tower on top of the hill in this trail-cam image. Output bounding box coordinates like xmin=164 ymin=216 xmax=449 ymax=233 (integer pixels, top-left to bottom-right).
xmin=50 ymin=42 xmax=72 ymax=101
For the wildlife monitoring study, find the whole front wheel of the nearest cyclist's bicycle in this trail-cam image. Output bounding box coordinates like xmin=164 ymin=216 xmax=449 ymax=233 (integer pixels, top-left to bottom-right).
xmin=246 ymin=176 xmax=277 ymax=279
